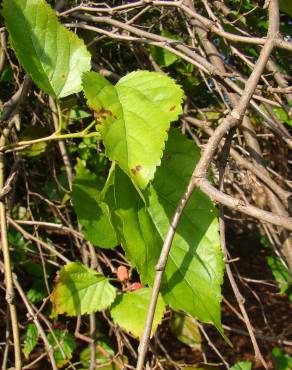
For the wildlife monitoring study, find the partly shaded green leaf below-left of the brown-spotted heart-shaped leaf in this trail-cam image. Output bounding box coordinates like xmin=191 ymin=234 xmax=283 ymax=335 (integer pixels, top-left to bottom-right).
xmin=72 ymin=165 xmax=118 ymax=248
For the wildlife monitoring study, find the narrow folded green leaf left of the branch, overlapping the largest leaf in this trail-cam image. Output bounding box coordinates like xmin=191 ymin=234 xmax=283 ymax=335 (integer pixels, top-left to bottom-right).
xmin=105 ymin=167 xmax=161 ymax=284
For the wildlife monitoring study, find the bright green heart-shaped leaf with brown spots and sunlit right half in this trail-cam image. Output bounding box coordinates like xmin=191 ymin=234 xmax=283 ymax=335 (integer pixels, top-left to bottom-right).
xmin=83 ymin=71 xmax=183 ymax=188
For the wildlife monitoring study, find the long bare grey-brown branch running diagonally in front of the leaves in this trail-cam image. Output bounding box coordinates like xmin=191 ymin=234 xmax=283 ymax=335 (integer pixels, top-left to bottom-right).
xmin=136 ymin=0 xmax=284 ymax=370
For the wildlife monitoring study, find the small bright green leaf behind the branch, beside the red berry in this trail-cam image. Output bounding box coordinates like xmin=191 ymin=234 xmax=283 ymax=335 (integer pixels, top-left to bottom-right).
xmin=110 ymin=288 xmax=165 ymax=338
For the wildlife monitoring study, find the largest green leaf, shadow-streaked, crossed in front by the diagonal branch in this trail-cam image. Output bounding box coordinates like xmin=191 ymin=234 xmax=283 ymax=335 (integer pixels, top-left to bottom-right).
xmin=148 ymin=131 xmax=224 ymax=330
